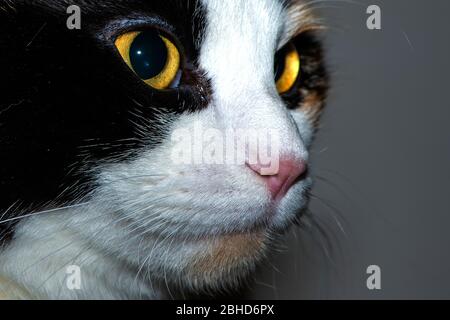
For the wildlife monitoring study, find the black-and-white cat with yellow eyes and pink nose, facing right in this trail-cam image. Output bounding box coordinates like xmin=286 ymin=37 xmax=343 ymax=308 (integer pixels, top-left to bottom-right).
xmin=0 ymin=0 xmax=329 ymax=299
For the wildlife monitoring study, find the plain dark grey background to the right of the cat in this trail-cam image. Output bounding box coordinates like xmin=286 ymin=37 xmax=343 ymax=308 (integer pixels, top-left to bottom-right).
xmin=251 ymin=0 xmax=450 ymax=299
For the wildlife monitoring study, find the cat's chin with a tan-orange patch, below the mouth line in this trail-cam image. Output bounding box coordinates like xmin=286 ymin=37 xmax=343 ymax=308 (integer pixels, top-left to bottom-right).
xmin=149 ymin=229 xmax=273 ymax=294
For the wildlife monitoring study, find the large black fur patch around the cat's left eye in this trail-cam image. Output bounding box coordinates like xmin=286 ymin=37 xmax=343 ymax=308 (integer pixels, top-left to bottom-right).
xmin=0 ymin=0 xmax=210 ymax=242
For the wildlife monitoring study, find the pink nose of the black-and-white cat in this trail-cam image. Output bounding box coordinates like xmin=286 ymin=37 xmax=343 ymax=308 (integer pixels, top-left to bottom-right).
xmin=247 ymin=158 xmax=307 ymax=200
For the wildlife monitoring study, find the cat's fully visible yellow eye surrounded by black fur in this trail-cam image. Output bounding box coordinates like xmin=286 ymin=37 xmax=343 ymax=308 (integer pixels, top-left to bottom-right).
xmin=115 ymin=30 xmax=180 ymax=90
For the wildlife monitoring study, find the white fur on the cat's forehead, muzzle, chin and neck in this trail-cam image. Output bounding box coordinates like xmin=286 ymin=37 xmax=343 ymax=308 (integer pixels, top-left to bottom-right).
xmin=0 ymin=0 xmax=312 ymax=299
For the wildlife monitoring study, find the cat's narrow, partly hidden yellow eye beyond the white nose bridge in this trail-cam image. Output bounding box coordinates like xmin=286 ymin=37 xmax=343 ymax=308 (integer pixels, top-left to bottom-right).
xmin=275 ymin=43 xmax=300 ymax=94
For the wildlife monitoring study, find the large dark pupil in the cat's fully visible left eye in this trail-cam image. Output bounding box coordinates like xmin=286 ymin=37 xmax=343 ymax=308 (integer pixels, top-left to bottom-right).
xmin=130 ymin=30 xmax=167 ymax=80
